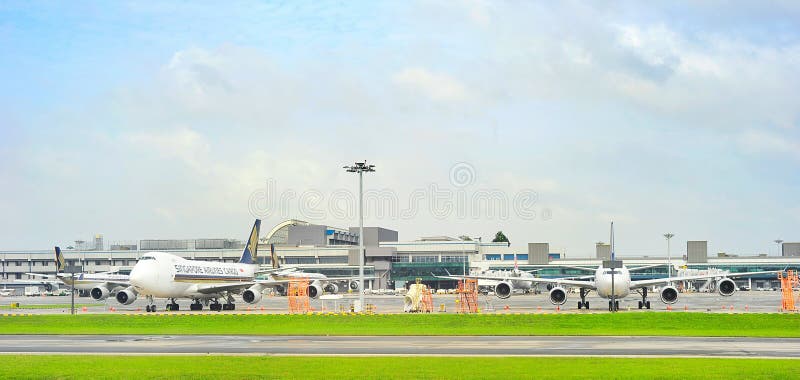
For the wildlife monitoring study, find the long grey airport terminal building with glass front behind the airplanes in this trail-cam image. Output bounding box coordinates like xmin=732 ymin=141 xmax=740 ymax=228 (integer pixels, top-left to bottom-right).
xmin=0 ymin=219 xmax=800 ymax=293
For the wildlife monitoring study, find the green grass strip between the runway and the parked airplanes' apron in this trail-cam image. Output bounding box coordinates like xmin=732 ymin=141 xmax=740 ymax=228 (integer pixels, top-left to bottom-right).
xmin=0 ymin=313 xmax=800 ymax=337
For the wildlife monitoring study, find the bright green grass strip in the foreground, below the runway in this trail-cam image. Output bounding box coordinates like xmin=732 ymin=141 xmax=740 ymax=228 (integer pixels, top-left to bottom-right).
xmin=0 ymin=355 xmax=798 ymax=380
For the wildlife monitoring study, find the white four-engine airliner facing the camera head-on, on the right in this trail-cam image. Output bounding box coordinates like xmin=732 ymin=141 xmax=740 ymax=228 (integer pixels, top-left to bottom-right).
xmin=456 ymin=222 xmax=776 ymax=310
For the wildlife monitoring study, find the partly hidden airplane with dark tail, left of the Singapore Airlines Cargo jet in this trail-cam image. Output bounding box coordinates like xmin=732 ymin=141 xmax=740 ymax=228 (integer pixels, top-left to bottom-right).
xmin=23 ymin=247 xmax=128 ymax=301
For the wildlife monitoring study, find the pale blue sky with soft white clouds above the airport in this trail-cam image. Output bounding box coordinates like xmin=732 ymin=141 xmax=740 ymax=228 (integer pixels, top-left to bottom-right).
xmin=0 ymin=0 xmax=800 ymax=257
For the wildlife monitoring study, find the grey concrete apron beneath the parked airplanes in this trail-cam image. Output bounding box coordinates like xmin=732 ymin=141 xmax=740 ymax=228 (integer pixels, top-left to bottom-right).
xmin=0 ymin=291 xmax=781 ymax=314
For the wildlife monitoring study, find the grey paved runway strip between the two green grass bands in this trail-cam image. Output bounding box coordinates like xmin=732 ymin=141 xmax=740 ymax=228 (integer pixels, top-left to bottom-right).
xmin=0 ymin=335 xmax=800 ymax=358
